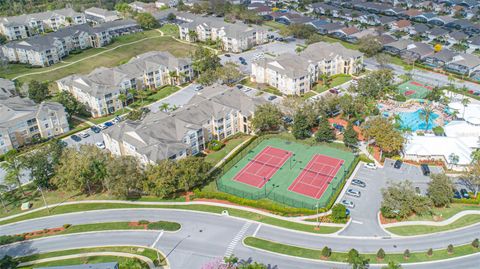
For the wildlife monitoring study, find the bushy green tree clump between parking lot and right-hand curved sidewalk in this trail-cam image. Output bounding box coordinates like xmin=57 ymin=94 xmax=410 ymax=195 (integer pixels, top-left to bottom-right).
xmin=380 ymin=180 xmax=432 ymax=220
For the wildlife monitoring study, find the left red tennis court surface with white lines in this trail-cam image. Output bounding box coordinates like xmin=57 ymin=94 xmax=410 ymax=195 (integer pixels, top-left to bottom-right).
xmin=233 ymin=146 xmax=292 ymax=188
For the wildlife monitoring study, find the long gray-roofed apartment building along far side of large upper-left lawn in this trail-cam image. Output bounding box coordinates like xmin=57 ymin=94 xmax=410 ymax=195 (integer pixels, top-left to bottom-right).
xmin=2 ymin=20 xmax=141 ymax=67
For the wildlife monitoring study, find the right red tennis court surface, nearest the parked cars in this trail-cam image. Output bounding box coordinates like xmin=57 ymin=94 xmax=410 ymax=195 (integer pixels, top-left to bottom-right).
xmin=288 ymin=154 xmax=343 ymax=199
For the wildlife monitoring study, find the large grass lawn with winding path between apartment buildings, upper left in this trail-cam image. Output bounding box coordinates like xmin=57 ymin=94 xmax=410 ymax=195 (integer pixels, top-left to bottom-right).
xmin=0 ymin=30 xmax=194 ymax=82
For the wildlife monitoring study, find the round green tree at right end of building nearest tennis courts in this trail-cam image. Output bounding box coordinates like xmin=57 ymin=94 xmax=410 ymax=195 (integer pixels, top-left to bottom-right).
xmin=252 ymin=103 xmax=283 ymax=132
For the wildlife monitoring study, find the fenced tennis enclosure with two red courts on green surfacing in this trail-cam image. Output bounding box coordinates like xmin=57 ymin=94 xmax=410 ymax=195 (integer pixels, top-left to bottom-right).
xmin=217 ymin=137 xmax=355 ymax=209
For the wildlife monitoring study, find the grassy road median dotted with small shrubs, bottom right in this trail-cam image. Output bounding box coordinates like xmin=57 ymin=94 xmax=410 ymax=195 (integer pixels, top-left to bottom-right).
xmin=243 ymin=237 xmax=480 ymax=264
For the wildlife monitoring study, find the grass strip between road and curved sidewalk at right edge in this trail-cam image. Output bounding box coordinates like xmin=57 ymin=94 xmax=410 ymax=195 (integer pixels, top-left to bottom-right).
xmin=387 ymin=215 xmax=480 ymax=236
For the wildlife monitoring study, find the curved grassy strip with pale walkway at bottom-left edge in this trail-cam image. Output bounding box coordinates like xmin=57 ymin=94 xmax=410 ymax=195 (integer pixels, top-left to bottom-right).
xmin=17 ymin=246 xmax=168 ymax=269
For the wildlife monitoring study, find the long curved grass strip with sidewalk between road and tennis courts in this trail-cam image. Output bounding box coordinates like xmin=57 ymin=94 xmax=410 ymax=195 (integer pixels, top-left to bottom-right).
xmin=0 ymin=201 xmax=344 ymax=234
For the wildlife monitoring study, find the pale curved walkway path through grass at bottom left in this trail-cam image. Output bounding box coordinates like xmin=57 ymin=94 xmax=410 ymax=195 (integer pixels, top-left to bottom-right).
xmin=19 ymin=252 xmax=162 ymax=269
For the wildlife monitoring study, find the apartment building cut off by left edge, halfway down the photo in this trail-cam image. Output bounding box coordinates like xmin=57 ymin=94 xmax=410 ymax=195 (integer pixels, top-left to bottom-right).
xmin=0 ymin=96 xmax=70 ymax=154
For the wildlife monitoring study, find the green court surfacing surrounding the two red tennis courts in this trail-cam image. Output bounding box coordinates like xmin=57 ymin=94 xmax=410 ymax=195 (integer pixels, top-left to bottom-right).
xmin=218 ymin=138 xmax=355 ymax=209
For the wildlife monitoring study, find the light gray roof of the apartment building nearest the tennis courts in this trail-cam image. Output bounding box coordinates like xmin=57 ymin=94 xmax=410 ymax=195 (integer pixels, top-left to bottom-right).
xmin=105 ymin=85 xmax=266 ymax=162
